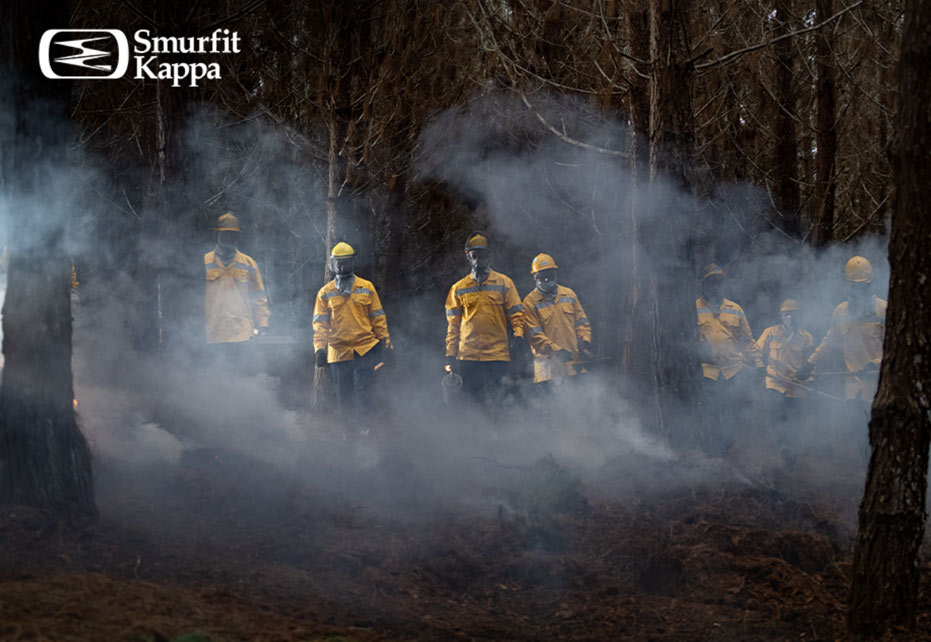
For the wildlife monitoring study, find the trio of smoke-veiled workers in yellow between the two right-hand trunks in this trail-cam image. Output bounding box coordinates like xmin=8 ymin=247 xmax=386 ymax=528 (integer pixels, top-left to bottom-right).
xmin=695 ymin=256 xmax=886 ymax=453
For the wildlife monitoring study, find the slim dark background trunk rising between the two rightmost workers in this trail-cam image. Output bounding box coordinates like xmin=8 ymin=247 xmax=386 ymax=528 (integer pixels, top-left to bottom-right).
xmin=811 ymin=0 xmax=837 ymax=246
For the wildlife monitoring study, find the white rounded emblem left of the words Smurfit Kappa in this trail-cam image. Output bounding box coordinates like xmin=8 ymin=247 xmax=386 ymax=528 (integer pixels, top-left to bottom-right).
xmin=39 ymin=29 xmax=130 ymax=80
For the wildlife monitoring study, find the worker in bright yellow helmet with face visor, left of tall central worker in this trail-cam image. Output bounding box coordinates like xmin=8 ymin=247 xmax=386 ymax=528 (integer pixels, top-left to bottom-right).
xmin=313 ymin=242 xmax=391 ymax=417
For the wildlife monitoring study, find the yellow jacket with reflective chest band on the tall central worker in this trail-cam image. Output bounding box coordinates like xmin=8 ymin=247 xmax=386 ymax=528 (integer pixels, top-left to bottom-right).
xmin=446 ymin=270 xmax=524 ymax=361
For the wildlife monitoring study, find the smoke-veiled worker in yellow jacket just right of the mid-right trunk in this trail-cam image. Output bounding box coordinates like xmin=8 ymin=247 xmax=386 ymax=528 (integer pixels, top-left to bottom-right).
xmin=695 ymin=263 xmax=764 ymax=455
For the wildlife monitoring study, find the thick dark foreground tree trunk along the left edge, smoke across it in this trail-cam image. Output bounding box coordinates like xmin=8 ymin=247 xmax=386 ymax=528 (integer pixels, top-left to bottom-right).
xmin=0 ymin=1 xmax=96 ymax=516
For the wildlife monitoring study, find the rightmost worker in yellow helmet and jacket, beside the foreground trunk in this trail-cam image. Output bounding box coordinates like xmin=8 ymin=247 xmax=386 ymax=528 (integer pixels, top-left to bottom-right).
xmin=798 ymin=256 xmax=886 ymax=404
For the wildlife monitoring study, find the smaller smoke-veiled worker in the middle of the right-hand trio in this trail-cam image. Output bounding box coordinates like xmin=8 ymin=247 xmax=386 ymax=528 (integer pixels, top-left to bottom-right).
xmin=756 ymin=299 xmax=815 ymax=423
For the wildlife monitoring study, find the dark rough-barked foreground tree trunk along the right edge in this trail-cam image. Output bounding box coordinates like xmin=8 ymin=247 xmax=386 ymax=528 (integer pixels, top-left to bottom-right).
xmin=848 ymin=0 xmax=931 ymax=639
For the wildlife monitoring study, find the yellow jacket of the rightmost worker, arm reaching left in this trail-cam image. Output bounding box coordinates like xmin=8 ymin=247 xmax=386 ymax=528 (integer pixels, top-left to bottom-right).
xmin=808 ymin=296 xmax=886 ymax=401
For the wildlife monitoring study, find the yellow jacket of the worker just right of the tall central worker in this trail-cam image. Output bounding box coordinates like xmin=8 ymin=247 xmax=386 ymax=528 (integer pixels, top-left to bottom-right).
xmin=524 ymin=285 xmax=592 ymax=383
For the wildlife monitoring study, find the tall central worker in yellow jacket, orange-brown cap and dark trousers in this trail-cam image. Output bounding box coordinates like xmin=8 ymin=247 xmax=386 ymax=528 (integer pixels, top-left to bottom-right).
xmin=446 ymin=233 xmax=524 ymax=404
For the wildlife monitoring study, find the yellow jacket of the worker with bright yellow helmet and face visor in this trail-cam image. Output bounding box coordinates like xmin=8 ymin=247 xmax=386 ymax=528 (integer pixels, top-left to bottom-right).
xmin=314 ymin=276 xmax=389 ymax=363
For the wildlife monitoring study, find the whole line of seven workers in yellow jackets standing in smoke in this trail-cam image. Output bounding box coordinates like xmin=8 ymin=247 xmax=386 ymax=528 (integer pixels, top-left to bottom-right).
xmin=204 ymin=214 xmax=886 ymax=452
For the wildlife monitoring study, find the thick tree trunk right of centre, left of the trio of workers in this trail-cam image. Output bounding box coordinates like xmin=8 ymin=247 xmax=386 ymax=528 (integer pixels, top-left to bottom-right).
xmin=644 ymin=0 xmax=704 ymax=445
